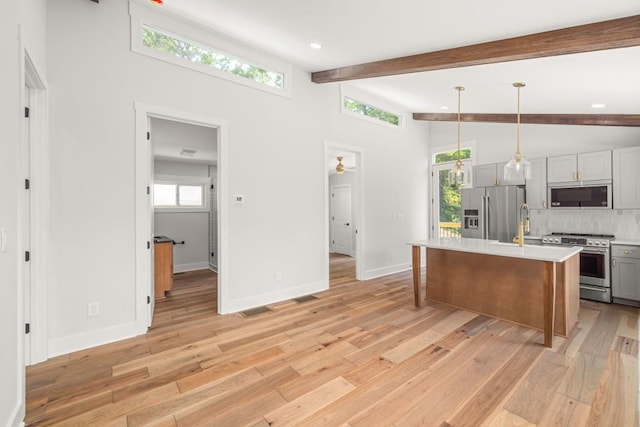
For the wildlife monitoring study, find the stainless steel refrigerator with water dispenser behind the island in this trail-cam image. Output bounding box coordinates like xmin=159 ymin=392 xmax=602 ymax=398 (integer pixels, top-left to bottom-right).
xmin=460 ymin=185 xmax=525 ymax=243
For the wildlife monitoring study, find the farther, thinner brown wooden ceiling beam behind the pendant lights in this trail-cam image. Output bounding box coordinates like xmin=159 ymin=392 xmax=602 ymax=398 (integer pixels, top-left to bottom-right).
xmin=413 ymin=113 xmax=640 ymax=127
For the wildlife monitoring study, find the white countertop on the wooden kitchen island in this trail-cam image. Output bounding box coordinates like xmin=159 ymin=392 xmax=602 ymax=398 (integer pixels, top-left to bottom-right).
xmin=408 ymin=237 xmax=582 ymax=262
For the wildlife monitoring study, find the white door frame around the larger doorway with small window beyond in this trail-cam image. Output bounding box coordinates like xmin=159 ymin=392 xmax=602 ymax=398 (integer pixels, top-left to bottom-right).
xmin=135 ymin=103 xmax=228 ymax=330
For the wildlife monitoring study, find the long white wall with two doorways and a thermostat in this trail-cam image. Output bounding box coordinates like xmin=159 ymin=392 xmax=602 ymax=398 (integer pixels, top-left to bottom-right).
xmin=48 ymin=0 xmax=427 ymax=354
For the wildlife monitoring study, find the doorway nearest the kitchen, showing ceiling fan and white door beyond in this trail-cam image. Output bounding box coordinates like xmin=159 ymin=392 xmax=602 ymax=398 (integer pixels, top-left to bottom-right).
xmin=325 ymin=142 xmax=364 ymax=287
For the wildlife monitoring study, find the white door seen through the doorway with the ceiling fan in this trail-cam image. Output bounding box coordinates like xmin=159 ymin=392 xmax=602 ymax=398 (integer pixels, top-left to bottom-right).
xmin=331 ymin=185 xmax=353 ymax=256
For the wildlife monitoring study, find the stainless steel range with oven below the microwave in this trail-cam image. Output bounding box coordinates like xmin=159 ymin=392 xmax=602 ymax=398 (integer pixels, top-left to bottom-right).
xmin=542 ymin=233 xmax=615 ymax=303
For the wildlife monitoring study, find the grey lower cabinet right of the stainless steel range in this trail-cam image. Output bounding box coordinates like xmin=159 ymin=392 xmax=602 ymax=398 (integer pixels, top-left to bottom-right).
xmin=611 ymin=245 xmax=640 ymax=305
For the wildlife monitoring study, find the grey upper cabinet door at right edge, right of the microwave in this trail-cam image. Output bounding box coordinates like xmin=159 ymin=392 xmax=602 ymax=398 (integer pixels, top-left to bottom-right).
xmin=613 ymin=147 xmax=640 ymax=209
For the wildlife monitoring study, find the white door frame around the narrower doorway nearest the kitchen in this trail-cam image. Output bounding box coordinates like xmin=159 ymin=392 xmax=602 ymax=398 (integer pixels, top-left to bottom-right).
xmin=322 ymin=141 xmax=366 ymax=288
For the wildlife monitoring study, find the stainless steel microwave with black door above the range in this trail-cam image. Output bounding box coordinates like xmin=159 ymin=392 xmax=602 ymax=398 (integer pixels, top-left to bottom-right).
xmin=549 ymin=183 xmax=612 ymax=209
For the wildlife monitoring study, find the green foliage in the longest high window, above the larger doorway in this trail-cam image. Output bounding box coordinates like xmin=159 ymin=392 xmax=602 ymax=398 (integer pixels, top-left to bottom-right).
xmin=142 ymin=25 xmax=284 ymax=89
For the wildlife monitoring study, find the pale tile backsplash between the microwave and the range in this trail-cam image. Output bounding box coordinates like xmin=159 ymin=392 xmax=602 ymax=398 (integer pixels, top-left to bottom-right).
xmin=530 ymin=209 xmax=640 ymax=240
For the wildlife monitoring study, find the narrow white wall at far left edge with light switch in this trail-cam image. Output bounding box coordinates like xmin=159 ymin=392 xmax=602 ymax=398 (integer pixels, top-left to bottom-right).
xmin=0 ymin=0 xmax=46 ymax=426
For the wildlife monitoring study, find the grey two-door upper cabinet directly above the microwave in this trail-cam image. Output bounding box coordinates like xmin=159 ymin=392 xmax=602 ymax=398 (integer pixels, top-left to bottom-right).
xmin=547 ymin=150 xmax=612 ymax=184
